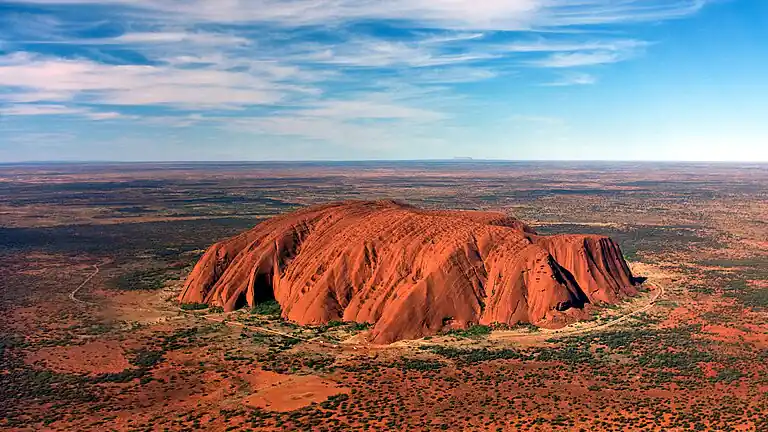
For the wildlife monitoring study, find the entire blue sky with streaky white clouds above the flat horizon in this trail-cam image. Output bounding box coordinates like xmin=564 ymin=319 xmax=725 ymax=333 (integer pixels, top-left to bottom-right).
xmin=0 ymin=0 xmax=768 ymax=161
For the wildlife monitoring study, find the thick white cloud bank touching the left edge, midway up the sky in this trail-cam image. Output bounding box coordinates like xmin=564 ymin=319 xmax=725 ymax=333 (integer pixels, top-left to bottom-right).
xmin=0 ymin=53 xmax=313 ymax=109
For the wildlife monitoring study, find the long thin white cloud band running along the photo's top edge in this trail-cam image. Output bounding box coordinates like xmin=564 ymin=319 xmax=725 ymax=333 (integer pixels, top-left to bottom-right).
xmin=10 ymin=0 xmax=711 ymax=30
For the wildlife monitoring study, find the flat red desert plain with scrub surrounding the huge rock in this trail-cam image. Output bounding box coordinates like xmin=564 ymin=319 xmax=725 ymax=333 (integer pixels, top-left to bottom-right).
xmin=0 ymin=161 xmax=768 ymax=431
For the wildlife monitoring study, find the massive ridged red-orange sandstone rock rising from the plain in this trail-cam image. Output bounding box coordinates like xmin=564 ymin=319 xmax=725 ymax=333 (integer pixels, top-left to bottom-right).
xmin=179 ymin=201 xmax=635 ymax=343
